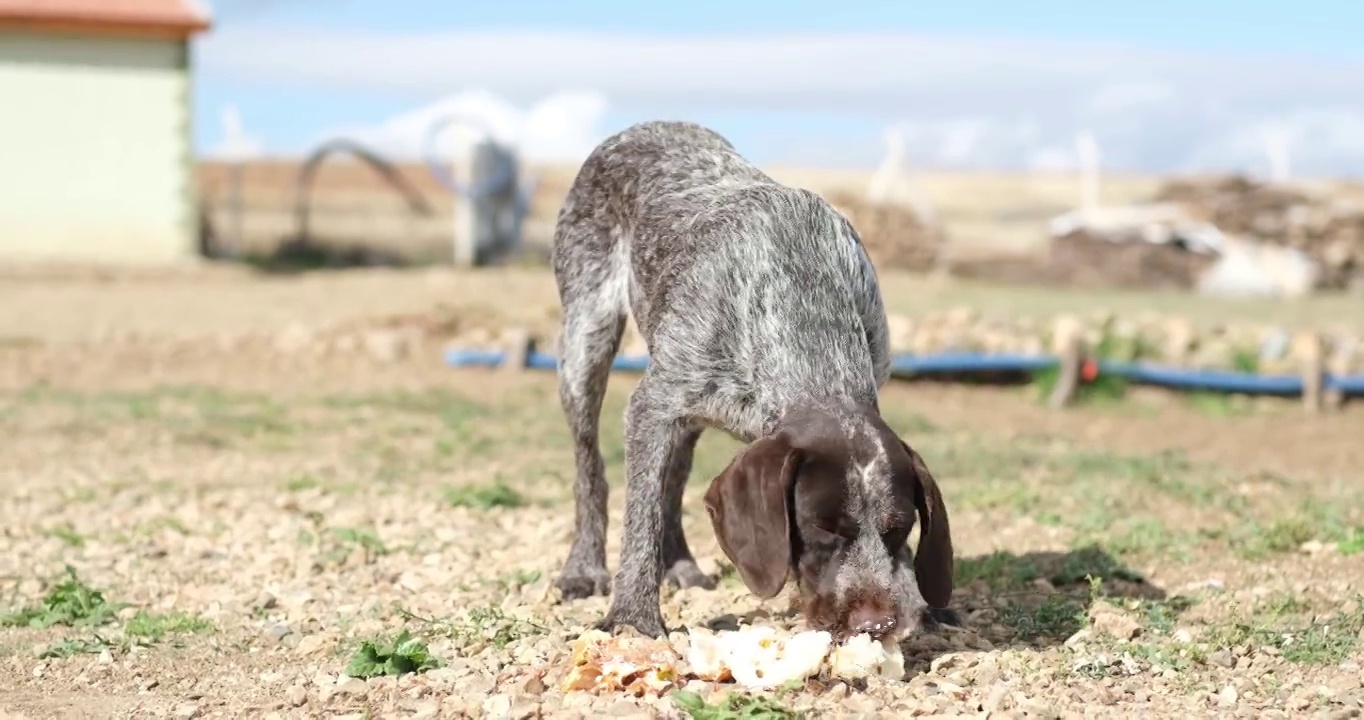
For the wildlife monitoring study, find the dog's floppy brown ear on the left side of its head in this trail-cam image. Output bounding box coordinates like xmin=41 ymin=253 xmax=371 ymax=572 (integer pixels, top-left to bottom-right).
xmin=705 ymin=438 xmax=801 ymax=600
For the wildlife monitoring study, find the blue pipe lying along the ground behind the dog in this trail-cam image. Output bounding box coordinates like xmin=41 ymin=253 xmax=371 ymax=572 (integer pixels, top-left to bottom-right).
xmin=445 ymin=349 xmax=1364 ymax=395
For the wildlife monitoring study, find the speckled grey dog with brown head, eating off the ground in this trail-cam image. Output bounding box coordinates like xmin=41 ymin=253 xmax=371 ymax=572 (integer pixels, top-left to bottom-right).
xmin=552 ymin=121 xmax=958 ymax=638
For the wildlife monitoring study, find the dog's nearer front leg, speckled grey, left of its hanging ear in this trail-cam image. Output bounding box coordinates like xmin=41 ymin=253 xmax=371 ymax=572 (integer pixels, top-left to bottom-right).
xmin=596 ymin=372 xmax=686 ymax=637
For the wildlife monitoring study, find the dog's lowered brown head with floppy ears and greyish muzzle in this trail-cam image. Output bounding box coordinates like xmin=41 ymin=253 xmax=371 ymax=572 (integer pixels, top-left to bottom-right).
xmin=705 ymin=413 xmax=952 ymax=638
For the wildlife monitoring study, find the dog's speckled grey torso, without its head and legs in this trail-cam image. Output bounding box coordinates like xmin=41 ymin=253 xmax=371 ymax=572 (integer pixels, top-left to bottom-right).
xmin=554 ymin=121 xmax=889 ymax=436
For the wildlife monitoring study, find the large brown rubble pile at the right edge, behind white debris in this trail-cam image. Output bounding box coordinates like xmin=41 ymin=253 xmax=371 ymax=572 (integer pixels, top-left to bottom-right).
xmin=1155 ymin=176 xmax=1364 ymax=289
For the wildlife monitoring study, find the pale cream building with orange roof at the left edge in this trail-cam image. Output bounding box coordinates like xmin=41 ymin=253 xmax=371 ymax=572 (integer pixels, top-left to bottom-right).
xmin=0 ymin=0 xmax=210 ymax=265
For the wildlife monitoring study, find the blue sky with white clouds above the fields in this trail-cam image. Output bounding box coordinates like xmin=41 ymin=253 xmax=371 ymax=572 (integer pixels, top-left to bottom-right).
xmin=194 ymin=0 xmax=1364 ymax=176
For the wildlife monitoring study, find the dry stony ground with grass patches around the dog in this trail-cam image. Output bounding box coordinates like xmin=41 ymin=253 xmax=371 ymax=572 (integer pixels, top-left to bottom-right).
xmin=0 ymin=270 xmax=1364 ymax=719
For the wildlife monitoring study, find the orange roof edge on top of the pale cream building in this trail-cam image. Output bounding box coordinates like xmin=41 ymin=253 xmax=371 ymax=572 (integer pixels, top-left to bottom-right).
xmin=0 ymin=0 xmax=210 ymax=37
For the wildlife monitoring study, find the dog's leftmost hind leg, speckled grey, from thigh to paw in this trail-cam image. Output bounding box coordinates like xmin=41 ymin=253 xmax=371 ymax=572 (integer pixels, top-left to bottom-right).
xmin=554 ymin=221 xmax=629 ymax=600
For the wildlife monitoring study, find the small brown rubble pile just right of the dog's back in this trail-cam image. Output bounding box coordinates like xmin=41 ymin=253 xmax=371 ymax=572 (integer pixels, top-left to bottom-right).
xmin=824 ymin=191 xmax=947 ymax=273
